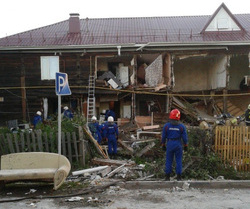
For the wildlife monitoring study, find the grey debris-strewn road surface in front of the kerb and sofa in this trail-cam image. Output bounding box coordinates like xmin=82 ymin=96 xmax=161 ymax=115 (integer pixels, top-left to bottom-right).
xmin=0 ymin=182 xmax=250 ymax=209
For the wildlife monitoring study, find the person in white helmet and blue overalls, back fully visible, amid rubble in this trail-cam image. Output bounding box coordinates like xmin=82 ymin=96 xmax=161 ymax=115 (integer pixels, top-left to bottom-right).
xmin=104 ymin=116 xmax=119 ymax=158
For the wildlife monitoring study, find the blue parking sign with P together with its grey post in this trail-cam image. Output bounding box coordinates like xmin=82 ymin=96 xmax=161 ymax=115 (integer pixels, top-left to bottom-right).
xmin=55 ymin=72 xmax=71 ymax=154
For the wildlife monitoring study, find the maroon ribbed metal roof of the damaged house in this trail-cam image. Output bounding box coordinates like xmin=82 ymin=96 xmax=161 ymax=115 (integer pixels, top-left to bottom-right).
xmin=0 ymin=14 xmax=250 ymax=50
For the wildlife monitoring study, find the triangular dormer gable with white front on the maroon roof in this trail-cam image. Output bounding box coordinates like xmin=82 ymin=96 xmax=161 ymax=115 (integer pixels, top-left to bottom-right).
xmin=202 ymin=3 xmax=243 ymax=32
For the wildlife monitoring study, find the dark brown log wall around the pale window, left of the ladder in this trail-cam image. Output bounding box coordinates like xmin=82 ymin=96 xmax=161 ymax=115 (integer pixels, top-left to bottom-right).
xmin=0 ymin=52 xmax=90 ymax=126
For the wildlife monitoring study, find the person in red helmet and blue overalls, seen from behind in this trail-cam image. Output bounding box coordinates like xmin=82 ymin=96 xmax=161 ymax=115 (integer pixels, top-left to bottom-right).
xmin=161 ymin=109 xmax=188 ymax=181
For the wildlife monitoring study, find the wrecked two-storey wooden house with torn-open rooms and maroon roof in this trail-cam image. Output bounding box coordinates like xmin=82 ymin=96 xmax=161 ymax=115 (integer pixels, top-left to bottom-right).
xmin=0 ymin=4 xmax=250 ymax=125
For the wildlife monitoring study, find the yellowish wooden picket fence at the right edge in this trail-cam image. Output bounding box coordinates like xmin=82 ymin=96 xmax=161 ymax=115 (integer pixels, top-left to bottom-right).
xmin=215 ymin=126 xmax=250 ymax=171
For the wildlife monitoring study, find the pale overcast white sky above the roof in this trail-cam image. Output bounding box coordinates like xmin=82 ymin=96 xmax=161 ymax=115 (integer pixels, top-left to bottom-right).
xmin=0 ymin=0 xmax=250 ymax=38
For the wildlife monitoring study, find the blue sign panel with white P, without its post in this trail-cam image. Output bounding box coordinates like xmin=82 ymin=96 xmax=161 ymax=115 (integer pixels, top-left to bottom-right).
xmin=56 ymin=72 xmax=71 ymax=95
